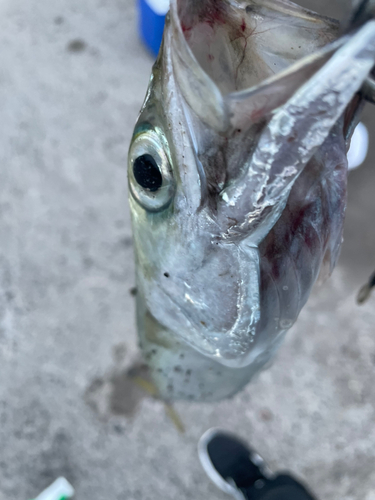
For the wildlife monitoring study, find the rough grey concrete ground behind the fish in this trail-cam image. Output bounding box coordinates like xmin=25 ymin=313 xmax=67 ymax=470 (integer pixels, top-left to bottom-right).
xmin=0 ymin=0 xmax=375 ymax=500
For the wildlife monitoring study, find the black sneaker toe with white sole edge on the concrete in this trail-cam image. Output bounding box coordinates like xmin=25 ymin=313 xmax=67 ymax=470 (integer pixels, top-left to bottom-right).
xmin=198 ymin=429 xmax=271 ymax=500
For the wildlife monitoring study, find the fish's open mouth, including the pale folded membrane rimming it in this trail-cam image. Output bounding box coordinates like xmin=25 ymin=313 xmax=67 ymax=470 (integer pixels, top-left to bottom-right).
xmin=169 ymin=0 xmax=343 ymax=132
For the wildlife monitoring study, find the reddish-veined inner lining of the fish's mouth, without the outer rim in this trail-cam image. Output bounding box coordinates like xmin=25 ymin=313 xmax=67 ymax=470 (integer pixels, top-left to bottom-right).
xmin=177 ymin=0 xmax=339 ymax=95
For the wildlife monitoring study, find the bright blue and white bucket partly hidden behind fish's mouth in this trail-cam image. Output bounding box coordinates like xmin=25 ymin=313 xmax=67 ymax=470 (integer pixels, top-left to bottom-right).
xmin=138 ymin=0 xmax=169 ymax=56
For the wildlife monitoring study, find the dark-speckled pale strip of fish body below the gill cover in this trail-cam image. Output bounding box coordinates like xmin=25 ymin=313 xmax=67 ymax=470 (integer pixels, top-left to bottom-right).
xmin=137 ymin=288 xmax=285 ymax=402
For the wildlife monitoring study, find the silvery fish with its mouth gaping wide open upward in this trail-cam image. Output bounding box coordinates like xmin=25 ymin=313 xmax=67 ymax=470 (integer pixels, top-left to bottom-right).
xmin=128 ymin=0 xmax=375 ymax=402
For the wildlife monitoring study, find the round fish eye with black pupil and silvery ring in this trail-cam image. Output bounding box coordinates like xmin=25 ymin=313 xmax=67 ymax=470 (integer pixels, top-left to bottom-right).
xmin=128 ymin=130 xmax=174 ymax=212
